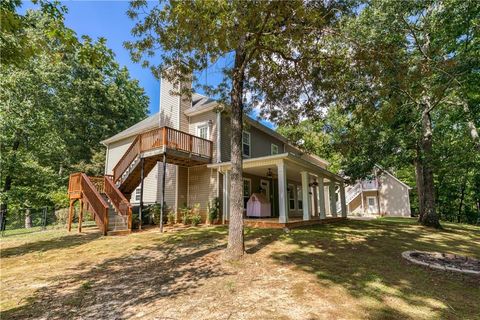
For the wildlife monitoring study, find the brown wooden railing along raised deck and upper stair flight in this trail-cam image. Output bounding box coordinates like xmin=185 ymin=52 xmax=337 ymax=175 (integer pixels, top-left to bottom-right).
xmin=113 ymin=127 xmax=213 ymax=182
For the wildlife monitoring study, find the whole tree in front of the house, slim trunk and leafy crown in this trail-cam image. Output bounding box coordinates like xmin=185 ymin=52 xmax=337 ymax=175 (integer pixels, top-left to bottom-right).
xmin=125 ymin=0 xmax=346 ymax=259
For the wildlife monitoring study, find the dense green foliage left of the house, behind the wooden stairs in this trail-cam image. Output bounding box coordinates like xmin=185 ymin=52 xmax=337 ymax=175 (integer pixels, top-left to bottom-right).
xmin=0 ymin=5 xmax=148 ymax=207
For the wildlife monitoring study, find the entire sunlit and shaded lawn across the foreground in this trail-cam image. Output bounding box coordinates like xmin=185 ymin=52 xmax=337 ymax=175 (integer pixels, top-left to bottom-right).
xmin=0 ymin=218 xmax=480 ymax=319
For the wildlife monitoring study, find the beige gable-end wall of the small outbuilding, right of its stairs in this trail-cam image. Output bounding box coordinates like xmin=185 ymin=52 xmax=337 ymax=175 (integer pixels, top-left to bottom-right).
xmin=379 ymin=174 xmax=410 ymax=217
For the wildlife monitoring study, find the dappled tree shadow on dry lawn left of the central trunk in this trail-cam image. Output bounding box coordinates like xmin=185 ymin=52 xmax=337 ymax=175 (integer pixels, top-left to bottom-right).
xmin=2 ymin=228 xmax=232 ymax=319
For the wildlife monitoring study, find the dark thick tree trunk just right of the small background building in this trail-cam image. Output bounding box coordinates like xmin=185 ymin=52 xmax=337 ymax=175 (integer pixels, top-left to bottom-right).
xmin=420 ymin=110 xmax=440 ymax=228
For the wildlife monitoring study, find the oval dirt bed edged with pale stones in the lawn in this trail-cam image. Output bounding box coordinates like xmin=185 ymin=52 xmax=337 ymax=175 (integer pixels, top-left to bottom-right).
xmin=402 ymin=251 xmax=480 ymax=275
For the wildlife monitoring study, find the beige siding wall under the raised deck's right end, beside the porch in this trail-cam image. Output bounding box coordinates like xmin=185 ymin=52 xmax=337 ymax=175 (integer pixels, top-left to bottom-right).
xmin=188 ymin=166 xmax=218 ymax=220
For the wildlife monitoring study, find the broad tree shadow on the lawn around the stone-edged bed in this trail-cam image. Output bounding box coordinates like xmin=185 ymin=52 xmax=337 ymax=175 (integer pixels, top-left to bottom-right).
xmin=271 ymin=219 xmax=480 ymax=319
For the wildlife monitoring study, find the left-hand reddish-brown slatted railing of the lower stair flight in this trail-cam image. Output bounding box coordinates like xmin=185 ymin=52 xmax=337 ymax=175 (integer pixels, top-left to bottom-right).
xmin=80 ymin=173 xmax=109 ymax=235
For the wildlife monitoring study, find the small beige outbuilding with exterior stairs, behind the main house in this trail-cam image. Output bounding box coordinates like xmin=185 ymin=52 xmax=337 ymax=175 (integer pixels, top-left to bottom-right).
xmin=346 ymin=165 xmax=412 ymax=217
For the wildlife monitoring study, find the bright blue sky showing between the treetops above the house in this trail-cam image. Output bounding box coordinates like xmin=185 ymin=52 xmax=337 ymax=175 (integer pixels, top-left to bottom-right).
xmin=19 ymin=1 xmax=274 ymax=128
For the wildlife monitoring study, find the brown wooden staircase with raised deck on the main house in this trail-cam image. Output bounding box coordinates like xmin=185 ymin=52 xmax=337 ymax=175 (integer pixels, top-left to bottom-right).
xmin=68 ymin=127 xmax=213 ymax=235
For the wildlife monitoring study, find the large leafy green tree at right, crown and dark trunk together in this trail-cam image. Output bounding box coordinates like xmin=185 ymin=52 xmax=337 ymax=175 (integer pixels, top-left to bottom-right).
xmin=274 ymin=0 xmax=480 ymax=227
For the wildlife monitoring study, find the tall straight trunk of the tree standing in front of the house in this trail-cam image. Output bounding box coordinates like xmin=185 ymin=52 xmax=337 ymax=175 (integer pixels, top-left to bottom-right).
xmin=225 ymin=48 xmax=245 ymax=260
